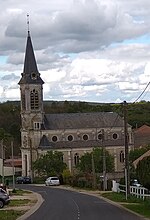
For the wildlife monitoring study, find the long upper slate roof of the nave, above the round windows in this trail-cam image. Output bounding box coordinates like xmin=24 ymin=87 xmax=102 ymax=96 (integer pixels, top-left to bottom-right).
xmin=44 ymin=112 xmax=129 ymax=130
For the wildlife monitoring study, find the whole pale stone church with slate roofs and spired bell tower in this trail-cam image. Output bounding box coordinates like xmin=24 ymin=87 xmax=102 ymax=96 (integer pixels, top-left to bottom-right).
xmin=18 ymin=30 xmax=133 ymax=176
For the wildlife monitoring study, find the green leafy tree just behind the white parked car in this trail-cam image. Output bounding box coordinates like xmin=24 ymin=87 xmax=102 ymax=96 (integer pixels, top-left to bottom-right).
xmin=33 ymin=151 xmax=67 ymax=176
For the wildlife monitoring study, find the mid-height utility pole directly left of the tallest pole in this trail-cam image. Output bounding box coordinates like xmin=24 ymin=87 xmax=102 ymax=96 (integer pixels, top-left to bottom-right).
xmin=102 ymin=129 xmax=107 ymax=191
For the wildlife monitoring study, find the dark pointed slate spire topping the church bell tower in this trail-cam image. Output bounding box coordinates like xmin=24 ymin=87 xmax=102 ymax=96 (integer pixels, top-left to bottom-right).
xmin=19 ymin=31 xmax=44 ymax=84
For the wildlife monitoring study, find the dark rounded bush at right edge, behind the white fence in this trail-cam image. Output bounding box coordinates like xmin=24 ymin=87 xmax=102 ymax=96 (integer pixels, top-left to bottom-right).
xmin=136 ymin=157 xmax=150 ymax=189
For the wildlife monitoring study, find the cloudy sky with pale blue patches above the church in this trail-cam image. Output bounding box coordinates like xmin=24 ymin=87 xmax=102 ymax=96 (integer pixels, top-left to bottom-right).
xmin=0 ymin=0 xmax=150 ymax=103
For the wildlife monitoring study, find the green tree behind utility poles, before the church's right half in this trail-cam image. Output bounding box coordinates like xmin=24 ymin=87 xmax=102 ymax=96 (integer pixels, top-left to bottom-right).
xmin=77 ymin=148 xmax=114 ymax=173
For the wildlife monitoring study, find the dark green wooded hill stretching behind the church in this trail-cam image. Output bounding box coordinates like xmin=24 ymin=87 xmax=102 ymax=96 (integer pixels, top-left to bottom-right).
xmin=0 ymin=101 xmax=150 ymax=158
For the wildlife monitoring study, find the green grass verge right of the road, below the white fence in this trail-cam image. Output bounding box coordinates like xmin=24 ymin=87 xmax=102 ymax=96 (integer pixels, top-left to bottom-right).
xmin=101 ymin=192 xmax=150 ymax=218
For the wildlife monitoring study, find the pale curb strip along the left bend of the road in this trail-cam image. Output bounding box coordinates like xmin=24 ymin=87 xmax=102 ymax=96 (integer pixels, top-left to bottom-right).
xmin=17 ymin=192 xmax=44 ymax=220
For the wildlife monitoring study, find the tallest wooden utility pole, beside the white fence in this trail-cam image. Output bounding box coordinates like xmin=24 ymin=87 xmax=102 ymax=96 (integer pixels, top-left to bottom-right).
xmin=124 ymin=101 xmax=130 ymax=200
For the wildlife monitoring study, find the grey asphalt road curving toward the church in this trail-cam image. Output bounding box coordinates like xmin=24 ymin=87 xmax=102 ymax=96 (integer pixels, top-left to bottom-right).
xmin=20 ymin=185 xmax=144 ymax=220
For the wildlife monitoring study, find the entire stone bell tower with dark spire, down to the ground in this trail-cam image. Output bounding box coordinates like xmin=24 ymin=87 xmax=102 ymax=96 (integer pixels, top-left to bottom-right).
xmin=18 ymin=23 xmax=44 ymax=177
